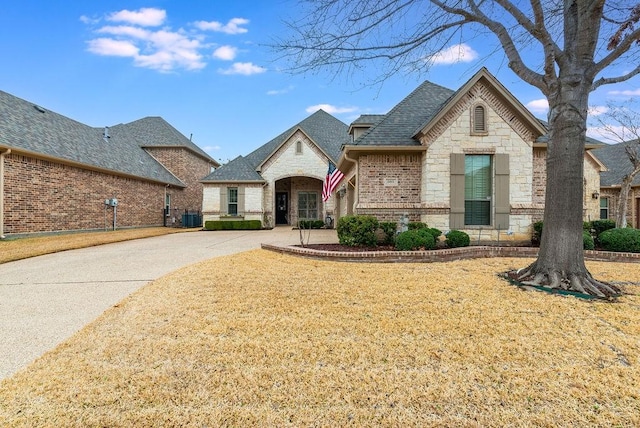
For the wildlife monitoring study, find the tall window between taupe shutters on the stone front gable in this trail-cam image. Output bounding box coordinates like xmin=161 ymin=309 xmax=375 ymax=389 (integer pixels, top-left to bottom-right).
xmin=464 ymin=155 xmax=492 ymax=226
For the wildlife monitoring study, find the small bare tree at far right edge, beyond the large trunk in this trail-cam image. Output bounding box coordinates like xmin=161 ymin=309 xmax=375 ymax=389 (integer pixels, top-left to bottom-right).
xmin=598 ymin=100 xmax=640 ymax=228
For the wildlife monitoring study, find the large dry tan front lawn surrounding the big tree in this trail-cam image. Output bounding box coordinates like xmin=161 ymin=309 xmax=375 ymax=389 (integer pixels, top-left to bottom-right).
xmin=0 ymin=250 xmax=640 ymax=427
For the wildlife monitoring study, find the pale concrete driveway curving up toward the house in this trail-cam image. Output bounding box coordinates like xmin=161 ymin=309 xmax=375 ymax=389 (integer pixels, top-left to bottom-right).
xmin=0 ymin=227 xmax=338 ymax=380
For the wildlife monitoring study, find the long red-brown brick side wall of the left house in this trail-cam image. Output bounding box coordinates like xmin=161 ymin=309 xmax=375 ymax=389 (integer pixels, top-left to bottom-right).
xmin=4 ymin=154 xmax=170 ymax=234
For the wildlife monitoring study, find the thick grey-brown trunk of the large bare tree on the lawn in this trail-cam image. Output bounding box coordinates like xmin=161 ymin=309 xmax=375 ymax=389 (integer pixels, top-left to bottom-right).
xmin=520 ymin=73 xmax=619 ymax=298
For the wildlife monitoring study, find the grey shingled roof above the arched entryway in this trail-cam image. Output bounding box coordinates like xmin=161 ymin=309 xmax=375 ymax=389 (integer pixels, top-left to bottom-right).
xmin=202 ymin=110 xmax=349 ymax=182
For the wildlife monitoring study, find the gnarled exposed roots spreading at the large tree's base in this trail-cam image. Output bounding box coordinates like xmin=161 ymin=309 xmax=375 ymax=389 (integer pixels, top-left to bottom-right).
xmin=506 ymin=264 xmax=622 ymax=299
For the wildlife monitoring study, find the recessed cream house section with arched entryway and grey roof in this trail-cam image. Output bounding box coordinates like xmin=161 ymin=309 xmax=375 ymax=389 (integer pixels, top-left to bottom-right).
xmin=202 ymin=110 xmax=348 ymax=227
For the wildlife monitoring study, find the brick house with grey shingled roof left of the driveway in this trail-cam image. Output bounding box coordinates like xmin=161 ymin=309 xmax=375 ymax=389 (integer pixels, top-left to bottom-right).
xmin=0 ymin=91 xmax=218 ymax=235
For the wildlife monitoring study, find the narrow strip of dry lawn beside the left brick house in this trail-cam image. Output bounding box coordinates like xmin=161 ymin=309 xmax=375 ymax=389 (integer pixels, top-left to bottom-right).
xmin=0 ymin=227 xmax=186 ymax=263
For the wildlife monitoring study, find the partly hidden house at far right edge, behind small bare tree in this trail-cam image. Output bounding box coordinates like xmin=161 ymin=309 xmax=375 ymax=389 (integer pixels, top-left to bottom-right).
xmin=593 ymin=141 xmax=640 ymax=229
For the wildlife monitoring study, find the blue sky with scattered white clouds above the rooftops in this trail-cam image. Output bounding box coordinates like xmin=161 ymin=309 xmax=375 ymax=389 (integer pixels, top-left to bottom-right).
xmin=0 ymin=0 xmax=640 ymax=162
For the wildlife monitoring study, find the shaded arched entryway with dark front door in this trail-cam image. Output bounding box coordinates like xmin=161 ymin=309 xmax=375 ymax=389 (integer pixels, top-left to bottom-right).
xmin=274 ymin=176 xmax=326 ymax=226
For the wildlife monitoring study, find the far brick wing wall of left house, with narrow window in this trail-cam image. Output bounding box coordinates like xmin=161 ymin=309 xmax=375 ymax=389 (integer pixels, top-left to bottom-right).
xmin=145 ymin=147 xmax=211 ymax=214
